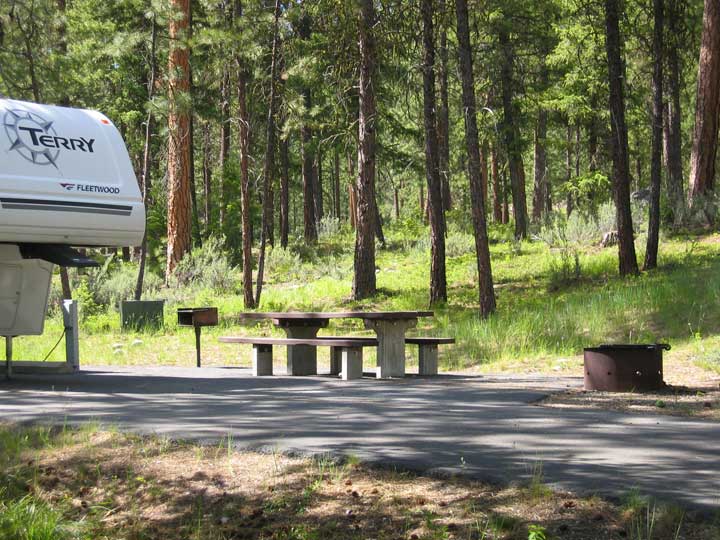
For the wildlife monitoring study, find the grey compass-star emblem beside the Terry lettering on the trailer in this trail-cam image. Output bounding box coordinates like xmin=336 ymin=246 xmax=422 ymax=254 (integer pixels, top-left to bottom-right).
xmin=4 ymin=109 xmax=60 ymax=169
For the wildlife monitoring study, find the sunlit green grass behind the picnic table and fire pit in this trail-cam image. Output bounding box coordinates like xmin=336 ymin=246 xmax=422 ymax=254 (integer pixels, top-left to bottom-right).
xmin=4 ymin=229 xmax=720 ymax=371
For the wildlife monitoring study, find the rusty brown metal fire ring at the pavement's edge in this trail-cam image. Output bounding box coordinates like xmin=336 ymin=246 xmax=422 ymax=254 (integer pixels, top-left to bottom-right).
xmin=585 ymin=343 xmax=670 ymax=392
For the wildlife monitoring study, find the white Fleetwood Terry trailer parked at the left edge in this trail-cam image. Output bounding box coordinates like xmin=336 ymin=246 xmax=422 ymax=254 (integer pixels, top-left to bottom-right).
xmin=0 ymin=99 xmax=145 ymax=344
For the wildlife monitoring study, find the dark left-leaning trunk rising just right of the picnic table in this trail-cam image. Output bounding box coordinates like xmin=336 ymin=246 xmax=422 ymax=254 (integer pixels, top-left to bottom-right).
xmin=455 ymin=0 xmax=495 ymax=317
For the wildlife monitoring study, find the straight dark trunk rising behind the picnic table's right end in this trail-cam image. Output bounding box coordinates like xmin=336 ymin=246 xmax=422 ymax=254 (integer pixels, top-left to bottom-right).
xmin=420 ymin=0 xmax=447 ymax=305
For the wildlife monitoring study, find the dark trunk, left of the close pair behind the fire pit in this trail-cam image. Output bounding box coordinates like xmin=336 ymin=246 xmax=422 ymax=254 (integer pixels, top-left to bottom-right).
xmin=605 ymin=0 xmax=638 ymax=276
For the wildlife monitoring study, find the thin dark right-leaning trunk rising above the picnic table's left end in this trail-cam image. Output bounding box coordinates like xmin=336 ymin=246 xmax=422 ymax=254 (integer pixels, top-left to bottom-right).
xmin=255 ymin=0 xmax=280 ymax=306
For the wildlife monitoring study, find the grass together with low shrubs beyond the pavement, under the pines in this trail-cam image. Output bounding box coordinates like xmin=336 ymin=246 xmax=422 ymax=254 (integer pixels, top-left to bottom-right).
xmin=8 ymin=207 xmax=720 ymax=380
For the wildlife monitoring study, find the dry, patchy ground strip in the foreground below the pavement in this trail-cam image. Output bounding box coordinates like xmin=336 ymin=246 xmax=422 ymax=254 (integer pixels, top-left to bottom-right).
xmin=0 ymin=424 xmax=720 ymax=540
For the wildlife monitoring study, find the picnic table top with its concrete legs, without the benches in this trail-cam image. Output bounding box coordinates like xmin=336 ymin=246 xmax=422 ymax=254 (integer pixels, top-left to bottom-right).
xmin=238 ymin=311 xmax=434 ymax=379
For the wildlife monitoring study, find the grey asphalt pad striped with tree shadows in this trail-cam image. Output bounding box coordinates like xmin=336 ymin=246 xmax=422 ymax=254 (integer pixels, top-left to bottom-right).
xmin=0 ymin=367 xmax=720 ymax=510
